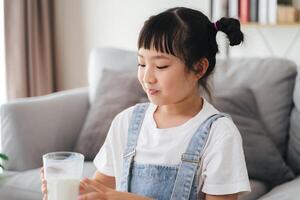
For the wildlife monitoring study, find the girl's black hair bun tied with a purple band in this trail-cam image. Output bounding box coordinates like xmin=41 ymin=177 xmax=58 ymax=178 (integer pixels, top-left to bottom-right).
xmin=212 ymin=17 xmax=244 ymax=46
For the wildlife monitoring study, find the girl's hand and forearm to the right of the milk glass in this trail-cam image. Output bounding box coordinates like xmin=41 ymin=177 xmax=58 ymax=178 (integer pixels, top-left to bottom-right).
xmin=77 ymin=178 xmax=150 ymax=200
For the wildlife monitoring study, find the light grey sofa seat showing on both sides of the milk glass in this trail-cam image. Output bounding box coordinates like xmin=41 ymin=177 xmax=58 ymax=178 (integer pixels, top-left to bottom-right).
xmin=0 ymin=162 xmax=96 ymax=200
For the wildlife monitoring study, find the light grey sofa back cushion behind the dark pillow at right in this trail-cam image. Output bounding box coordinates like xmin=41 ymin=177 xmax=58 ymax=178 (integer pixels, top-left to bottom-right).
xmin=213 ymin=58 xmax=297 ymax=155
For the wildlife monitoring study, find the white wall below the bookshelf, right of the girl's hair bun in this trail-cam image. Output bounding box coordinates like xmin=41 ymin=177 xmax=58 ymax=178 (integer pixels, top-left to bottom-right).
xmin=229 ymin=24 xmax=300 ymax=65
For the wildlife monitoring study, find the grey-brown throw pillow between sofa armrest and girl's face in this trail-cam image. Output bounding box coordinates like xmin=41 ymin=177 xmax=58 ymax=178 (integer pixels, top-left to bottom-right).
xmin=74 ymin=70 xmax=146 ymax=160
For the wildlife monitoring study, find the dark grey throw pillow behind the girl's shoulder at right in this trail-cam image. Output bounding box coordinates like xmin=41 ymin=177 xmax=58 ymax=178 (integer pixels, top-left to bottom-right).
xmin=213 ymin=88 xmax=294 ymax=185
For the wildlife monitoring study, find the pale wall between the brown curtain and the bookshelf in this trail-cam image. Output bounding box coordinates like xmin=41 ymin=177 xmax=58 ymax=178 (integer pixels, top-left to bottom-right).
xmin=55 ymin=0 xmax=210 ymax=90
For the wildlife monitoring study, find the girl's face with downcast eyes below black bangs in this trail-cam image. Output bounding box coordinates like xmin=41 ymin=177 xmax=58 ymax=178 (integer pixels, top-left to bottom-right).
xmin=138 ymin=48 xmax=199 ymax=105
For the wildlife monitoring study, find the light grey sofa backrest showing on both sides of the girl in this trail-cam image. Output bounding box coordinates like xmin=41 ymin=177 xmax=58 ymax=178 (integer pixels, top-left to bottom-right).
xmin=88 ymin=47 xmax=300 ymax=162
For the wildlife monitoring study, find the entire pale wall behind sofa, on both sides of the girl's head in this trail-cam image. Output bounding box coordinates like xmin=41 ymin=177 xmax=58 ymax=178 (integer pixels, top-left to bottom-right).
xmin=55 ymin=0 xmax=300 ymax=90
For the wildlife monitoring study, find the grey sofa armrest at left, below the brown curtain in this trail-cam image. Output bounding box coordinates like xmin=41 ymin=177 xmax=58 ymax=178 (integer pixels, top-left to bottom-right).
xmin=0 ymin=88 xmax=89 ymax=171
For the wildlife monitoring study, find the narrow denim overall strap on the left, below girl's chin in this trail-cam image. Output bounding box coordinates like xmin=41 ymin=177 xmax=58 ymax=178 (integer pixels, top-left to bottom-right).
xmin=120 ymin=103 xmax=149 ymax=192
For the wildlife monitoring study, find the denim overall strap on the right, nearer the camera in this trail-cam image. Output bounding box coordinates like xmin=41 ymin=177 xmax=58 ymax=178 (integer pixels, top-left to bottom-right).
xmin=171 ymin=113 xmax=228 ymax=200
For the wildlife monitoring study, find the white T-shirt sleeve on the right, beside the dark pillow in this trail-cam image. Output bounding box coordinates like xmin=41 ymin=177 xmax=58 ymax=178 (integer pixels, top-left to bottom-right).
xmin=201 ymin=119 xmax=250 ymax=195
